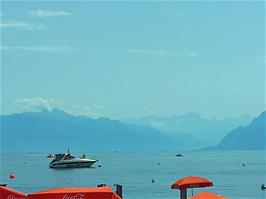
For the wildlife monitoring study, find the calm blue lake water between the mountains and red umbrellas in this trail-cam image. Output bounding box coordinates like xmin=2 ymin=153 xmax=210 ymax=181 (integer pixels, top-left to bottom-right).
xmin=0 ymin=151 xmax=266 ymax=199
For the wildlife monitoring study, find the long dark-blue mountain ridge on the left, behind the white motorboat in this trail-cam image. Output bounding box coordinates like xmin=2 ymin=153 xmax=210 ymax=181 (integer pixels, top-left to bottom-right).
xmin=1 ymin=109 xmax=187 ymax=152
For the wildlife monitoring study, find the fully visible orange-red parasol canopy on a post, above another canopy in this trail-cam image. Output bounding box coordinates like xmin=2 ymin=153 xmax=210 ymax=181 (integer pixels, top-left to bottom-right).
xmin=171 ymin=176 xmax=213 ymax=190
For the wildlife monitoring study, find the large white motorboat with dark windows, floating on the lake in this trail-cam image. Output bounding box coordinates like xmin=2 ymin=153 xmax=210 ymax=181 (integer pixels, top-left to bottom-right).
xmin=49 ymin=150 xmax=97 ymax=168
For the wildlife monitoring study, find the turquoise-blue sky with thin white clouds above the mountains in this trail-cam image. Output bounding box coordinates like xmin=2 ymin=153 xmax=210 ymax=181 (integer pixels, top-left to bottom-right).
xmin=0 ymin=1 xmax=265 ymax=119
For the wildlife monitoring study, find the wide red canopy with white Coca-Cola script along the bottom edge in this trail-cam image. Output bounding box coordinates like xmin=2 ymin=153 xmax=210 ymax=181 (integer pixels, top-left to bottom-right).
xmin=27 ymin=187 xmax=121 ymax=199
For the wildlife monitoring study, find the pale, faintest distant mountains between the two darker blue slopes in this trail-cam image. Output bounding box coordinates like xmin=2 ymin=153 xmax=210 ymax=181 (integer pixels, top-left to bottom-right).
xmin=126 ymin=112 xmax=252 ymax=145
